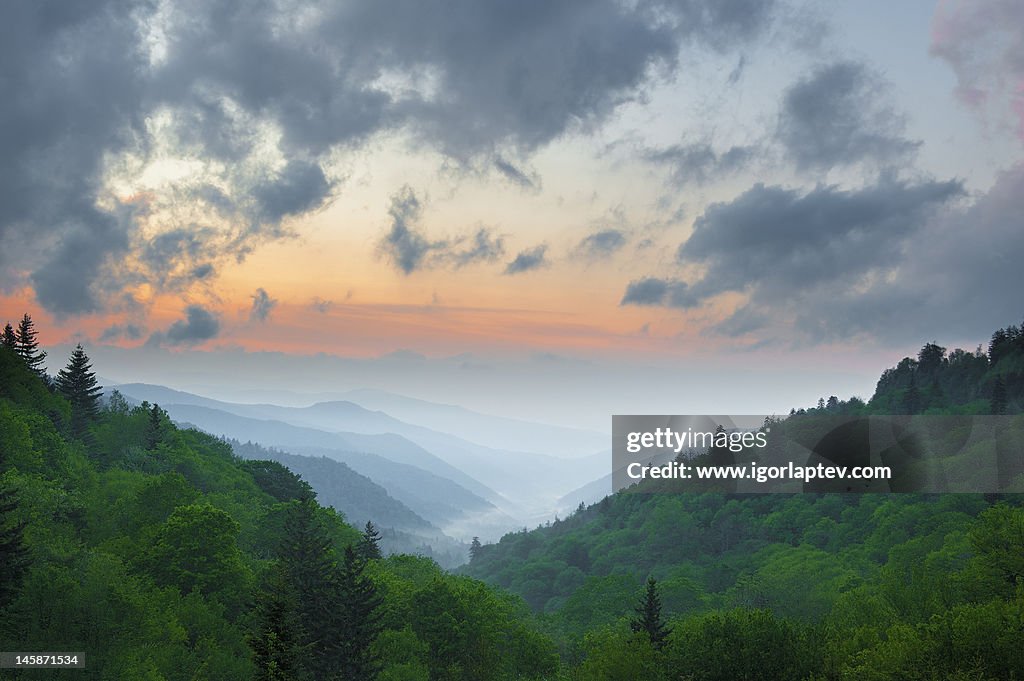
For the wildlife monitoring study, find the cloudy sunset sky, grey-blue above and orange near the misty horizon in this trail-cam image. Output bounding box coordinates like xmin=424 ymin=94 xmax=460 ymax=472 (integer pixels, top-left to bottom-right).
xmin=0 ymin=0 xmax=1024 ymax=427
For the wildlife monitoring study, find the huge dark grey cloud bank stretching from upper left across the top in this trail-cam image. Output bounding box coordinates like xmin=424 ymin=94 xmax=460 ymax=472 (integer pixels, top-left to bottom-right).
xmin=0 ymin=0 xmax=772 ymax=314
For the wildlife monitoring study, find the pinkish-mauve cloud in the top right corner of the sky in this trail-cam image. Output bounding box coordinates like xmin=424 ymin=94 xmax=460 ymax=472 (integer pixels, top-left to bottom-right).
xmin=931 ymin=0 xmax=1024 ymax=139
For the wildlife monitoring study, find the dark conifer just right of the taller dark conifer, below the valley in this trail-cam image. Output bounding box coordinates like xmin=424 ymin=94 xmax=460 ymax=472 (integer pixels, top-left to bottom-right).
xmin=340 ymin=545 xmax=384 ymax=681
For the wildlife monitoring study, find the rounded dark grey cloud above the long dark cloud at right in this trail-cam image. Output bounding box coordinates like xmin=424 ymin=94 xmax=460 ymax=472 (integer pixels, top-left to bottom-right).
xmin=776 ymin=61 xmax=920 ymax=170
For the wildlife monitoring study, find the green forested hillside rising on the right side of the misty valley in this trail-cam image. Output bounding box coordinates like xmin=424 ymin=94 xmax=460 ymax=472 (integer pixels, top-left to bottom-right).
xmin=464 ymin=327 xmax=1024 ymax=680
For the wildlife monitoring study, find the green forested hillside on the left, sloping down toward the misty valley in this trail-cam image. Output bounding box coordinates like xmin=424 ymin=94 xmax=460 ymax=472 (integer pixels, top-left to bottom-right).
xmin=0 ymin=319 xmax=558 ymax=681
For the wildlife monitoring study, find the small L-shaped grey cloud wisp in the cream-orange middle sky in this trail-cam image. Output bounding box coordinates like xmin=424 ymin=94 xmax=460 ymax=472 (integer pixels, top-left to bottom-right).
xmin=378 ymin=186 xmax=505 ymax=274
